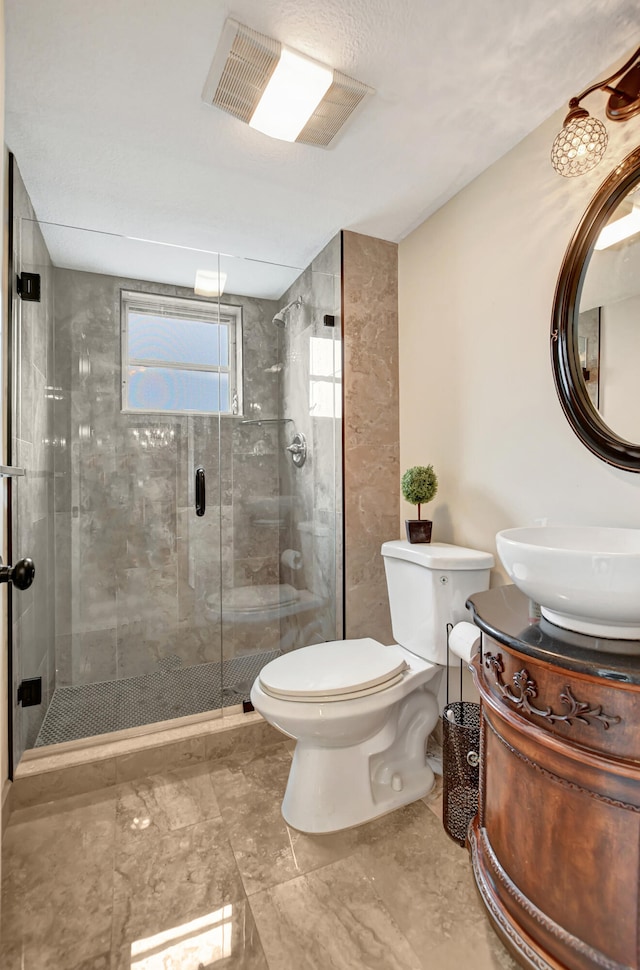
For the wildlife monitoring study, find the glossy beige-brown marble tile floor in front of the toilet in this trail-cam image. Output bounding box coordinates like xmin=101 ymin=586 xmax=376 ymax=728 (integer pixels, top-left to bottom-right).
xmin=0 ymin=741 xmax=516 ymax=970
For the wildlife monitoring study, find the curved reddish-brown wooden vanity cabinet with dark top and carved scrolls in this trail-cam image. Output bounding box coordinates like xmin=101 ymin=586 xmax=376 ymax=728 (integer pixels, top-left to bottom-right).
xmin=468 ymin=586 xmax=640 ymax=970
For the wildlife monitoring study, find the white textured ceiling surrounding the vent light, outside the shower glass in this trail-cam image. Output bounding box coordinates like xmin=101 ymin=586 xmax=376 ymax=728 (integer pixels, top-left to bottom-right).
xmin=5 ymin=0 xmax=640 ymax=296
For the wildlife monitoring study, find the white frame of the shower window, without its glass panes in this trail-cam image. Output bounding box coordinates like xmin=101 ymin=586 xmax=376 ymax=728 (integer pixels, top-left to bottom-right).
xmin=120 ymin=290 xmax=242 ymax=415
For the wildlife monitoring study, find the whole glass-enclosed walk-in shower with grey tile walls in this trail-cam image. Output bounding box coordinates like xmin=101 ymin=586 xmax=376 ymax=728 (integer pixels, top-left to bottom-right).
xmin=9 ymin=159 xmax=342 ymax=764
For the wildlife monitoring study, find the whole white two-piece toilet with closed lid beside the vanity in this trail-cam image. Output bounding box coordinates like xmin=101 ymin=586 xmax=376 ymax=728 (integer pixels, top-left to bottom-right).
xmin=251 ymin=539 xmax=493 ymax=833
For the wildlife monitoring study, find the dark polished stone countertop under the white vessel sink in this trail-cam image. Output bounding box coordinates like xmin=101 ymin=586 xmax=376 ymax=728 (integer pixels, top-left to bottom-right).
xmin=467 ymin=586 xmax=640 ymax=684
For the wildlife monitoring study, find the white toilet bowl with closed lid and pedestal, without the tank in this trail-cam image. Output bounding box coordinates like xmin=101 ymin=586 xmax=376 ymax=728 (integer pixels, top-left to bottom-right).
xmin=251 ymin=639 xmax=441 ymax=832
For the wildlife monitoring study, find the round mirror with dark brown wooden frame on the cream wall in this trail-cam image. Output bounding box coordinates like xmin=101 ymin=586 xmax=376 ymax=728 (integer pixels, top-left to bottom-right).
xmin=551 ymin=148 xmax=640 ymax=472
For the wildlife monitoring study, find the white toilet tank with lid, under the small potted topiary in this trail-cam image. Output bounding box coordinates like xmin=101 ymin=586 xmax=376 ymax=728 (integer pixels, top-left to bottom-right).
xmin=382 ymin=539 xmax=494 ymax=664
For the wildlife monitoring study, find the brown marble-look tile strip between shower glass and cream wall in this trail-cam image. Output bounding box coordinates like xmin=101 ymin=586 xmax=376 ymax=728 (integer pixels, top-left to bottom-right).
xmin=342 ymin=231 xmax=400 ymax=643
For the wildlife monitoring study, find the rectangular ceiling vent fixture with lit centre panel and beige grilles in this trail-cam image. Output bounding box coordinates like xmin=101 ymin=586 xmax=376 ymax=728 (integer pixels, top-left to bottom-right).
xmin=202 ymin=20 xmax=373 ymax=148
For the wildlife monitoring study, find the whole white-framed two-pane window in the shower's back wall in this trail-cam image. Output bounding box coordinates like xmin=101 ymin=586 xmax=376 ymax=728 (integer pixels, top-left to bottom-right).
xmin=121 ymin=290 xmax=242 ymax=414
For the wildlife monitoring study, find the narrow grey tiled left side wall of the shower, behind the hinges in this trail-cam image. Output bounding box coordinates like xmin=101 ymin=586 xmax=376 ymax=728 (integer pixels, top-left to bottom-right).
xmin=11 ymin=159 xmax=55 ymax=762
